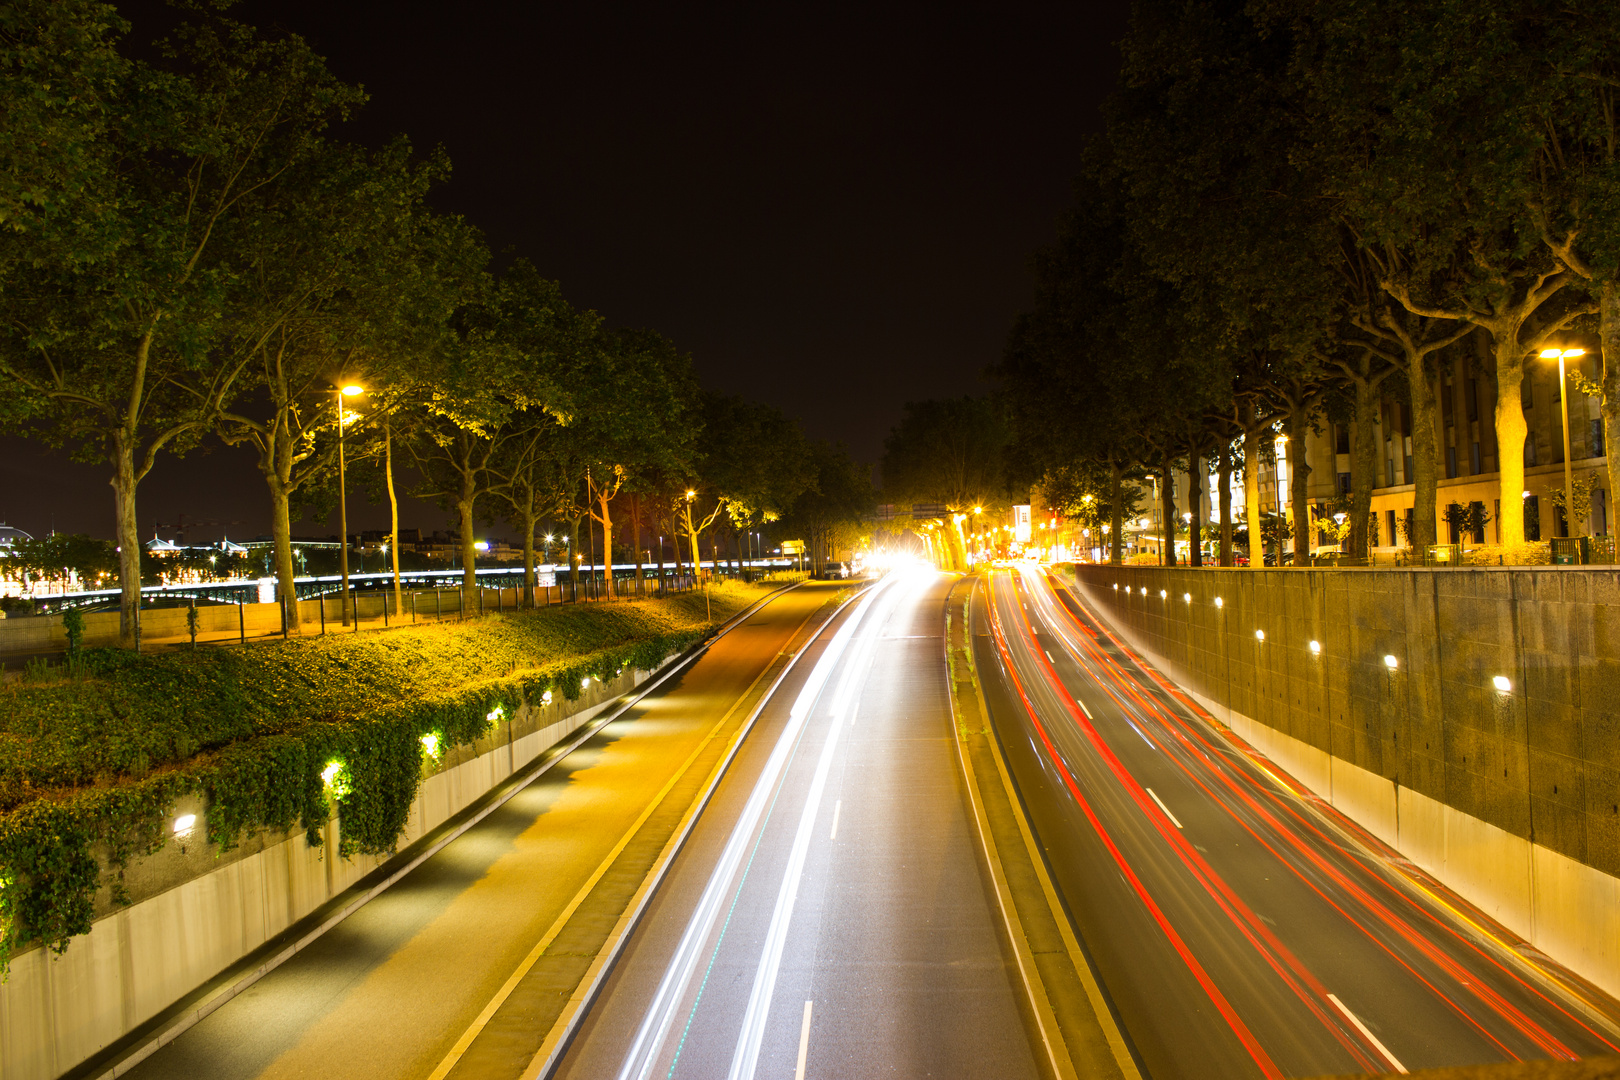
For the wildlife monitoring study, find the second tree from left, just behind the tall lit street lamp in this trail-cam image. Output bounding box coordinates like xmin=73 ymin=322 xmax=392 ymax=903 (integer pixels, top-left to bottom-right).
xmin=222 ymin=141 xmax=456 ymax=630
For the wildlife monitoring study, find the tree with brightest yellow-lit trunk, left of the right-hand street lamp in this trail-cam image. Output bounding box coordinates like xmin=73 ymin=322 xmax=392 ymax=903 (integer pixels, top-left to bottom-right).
xmin=1290 ymin=0 xmax=1597 ymax=544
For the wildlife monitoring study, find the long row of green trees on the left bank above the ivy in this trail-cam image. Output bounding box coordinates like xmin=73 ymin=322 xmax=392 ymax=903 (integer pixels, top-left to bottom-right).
xmin=0 ymin=0 xmax=870 ymax=638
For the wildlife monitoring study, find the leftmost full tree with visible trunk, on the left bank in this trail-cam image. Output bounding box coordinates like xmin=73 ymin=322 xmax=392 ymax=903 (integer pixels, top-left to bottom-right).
xmin=0 ymin=18 xmax=361 ymax=641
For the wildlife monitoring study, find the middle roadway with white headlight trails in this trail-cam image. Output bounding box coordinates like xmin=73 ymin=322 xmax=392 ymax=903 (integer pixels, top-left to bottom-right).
xmin=556 ymin=570 xmax=1037 ymax=1080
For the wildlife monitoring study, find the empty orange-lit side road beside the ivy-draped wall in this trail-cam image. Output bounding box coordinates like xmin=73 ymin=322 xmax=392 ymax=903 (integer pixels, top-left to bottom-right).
xmin=115 ymin=585 xmax=842 ymax=1080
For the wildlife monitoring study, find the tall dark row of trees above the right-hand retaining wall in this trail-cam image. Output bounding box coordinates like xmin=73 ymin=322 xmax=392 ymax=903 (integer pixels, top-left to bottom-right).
xmin=998 ymin=0 xmax=1620 ymax=562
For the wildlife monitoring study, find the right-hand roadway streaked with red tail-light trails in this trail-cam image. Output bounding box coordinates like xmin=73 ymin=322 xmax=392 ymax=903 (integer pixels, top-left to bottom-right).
xmin=974 ymin=567 xmax=1620 ymax=1078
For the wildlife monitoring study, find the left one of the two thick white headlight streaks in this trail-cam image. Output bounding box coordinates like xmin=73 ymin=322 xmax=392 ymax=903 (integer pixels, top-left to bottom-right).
xmin=619 ymin=580 xmax=888 ymax=1080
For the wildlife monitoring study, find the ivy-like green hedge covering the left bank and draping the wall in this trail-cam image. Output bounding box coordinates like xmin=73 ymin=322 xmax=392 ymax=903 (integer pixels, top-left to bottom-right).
xmin=0 ymin=585 xmax=763 ymax=973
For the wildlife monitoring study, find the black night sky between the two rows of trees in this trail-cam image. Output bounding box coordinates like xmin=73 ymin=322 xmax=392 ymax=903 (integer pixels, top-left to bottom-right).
xmin=0 ymin=0 xmax=1128 ymax=541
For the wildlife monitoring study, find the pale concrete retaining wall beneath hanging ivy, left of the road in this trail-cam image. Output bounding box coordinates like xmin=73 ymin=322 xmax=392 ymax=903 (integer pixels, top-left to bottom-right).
xmin=0 ymin=661 xmax=669 ymax=1080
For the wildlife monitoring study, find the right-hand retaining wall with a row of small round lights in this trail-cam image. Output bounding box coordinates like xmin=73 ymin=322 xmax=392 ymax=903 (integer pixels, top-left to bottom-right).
xmin=1072 ymin=565 xmax=1620 ymax=994
